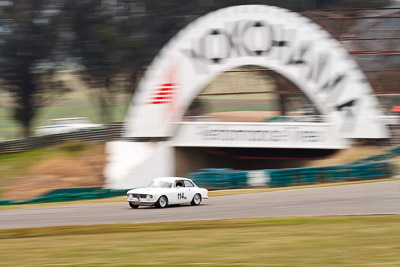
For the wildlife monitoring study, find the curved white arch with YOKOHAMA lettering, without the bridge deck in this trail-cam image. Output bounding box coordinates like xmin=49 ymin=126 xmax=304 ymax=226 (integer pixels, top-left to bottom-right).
xmin=125 ymin=5 xmax=387 ymax=138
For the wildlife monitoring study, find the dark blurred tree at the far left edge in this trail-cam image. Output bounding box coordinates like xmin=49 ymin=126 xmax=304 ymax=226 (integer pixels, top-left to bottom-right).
xmin=0 ymin=0 xmax=66 ymax=137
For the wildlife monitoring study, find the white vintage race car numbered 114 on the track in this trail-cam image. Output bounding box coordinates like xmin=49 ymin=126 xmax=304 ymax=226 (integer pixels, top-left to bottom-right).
xmin=127 ymin=177 xmax=208 ymax=209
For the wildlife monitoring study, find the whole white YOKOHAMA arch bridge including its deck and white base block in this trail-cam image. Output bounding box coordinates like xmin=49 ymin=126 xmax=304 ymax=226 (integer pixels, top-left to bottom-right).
xmin=105 ymin=5 xmax=387 ymax=188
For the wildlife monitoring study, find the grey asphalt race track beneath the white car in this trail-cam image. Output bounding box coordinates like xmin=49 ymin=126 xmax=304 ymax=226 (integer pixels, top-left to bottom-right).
xmin=0 ymin=180 xmax=400 ymax=229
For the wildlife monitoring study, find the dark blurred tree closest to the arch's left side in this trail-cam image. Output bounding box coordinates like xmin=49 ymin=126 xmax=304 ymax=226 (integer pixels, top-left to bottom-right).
xmin=64 ymin=0 xmax=142 ymax=123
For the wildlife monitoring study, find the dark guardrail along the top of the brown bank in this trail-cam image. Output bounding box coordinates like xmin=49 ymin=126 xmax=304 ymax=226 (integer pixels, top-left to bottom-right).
xmin=0 ymin=122 xmax=123 ymax=154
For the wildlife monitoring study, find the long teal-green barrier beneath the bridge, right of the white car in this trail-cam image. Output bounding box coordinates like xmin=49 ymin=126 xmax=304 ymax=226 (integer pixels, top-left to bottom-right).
xmin=189 ymin=161 xmax=395 ymax=189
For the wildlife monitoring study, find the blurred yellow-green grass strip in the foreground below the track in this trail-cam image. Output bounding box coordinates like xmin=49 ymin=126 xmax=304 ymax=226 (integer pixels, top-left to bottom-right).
xmin=0 ymin=215 xmax=400 ymax=266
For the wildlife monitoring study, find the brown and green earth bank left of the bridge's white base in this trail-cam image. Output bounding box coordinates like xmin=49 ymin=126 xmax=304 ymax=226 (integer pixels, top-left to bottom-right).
xmin=0 ymin=143 xmax=105 ymax=201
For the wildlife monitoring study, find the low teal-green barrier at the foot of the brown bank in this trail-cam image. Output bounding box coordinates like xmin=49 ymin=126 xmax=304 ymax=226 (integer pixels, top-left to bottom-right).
xmin=0 ymin=187 xmax=129 ymax=206
